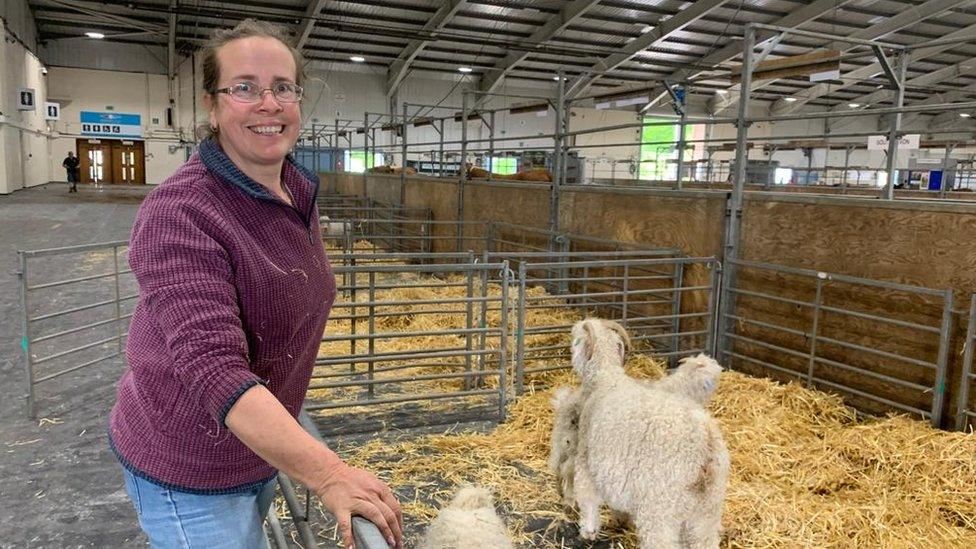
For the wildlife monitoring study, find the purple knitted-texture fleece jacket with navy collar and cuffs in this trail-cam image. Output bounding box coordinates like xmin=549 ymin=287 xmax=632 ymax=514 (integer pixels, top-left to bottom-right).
xmin=109 ymin=140 xmax=335 ymax=494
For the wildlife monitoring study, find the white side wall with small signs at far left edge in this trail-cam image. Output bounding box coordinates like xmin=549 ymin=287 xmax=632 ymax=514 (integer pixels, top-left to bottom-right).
xmin=0 ymin=18 xmax=50 ymax=194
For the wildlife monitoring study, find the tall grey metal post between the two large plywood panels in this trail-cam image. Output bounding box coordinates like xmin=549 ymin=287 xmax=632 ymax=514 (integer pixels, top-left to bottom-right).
xmin=718 ymin=25 xmax=756 ymax=361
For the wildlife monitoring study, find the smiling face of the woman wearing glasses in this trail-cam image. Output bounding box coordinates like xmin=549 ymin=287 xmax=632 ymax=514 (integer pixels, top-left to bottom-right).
xmin=207 ymin=36 xmax=301 ymax=172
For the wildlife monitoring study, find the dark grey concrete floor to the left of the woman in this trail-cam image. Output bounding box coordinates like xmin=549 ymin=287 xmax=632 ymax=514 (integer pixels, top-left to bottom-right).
xmin=0 ymin=184 xmax=150 ymax=549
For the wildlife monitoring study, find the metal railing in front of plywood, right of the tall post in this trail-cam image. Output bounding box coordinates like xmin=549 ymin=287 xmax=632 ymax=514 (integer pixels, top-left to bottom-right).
xmin=720 ymin=260 xmax=953 ymax=426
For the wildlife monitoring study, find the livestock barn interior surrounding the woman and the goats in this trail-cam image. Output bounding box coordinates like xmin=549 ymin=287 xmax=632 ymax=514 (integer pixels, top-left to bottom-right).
xmin=0 ymin=0 xmax=976 ymax=549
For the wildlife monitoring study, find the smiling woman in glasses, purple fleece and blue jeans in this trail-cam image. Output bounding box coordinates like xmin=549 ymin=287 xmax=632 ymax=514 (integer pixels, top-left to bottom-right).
xmin=109 ymin=20 xmax=402 ymax=549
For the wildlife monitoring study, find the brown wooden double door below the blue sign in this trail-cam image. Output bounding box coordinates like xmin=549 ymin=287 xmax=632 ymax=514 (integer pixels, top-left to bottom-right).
xmin=77 ymin=139 xmax=146 ymax=185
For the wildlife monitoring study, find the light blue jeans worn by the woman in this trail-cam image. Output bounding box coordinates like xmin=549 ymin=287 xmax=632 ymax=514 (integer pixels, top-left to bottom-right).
xmin=122 ymin=468 xmax=278 ymax=549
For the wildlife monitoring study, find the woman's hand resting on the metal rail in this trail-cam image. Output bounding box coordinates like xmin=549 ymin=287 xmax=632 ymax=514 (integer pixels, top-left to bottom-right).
xmin=311 ymin=462 xmax=403 ymax=549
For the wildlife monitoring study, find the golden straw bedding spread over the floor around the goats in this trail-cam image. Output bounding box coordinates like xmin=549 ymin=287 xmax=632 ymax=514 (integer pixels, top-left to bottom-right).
xmin=292 ymin=255 xmax=976 ymax=548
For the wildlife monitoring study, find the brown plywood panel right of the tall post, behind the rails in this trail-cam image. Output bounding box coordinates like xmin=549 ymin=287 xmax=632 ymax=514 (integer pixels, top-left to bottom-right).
xmin=740 ymin=197 xmax=976 ymax=424
